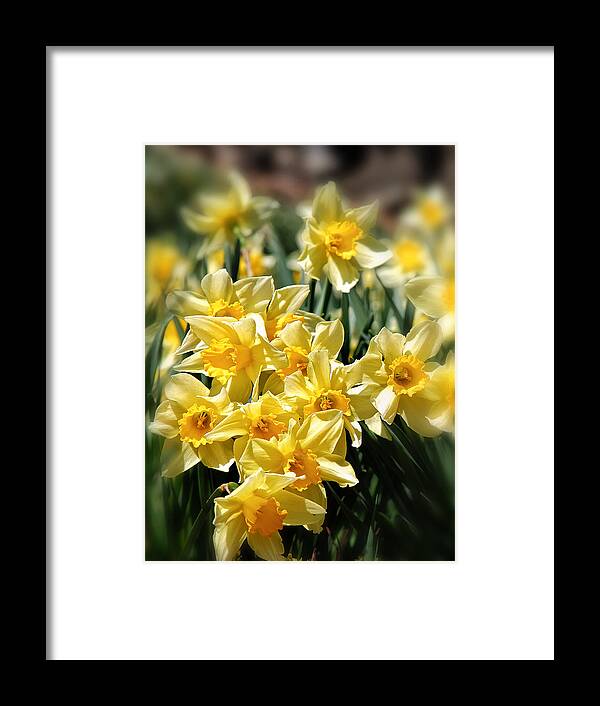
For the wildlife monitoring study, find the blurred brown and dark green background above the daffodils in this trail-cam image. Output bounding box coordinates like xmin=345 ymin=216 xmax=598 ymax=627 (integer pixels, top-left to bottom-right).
xmin=146 ymin=145 xmax=454 ymax=243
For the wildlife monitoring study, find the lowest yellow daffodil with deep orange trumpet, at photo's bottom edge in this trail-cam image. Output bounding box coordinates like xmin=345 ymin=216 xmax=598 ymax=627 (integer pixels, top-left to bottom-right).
xmin=213 ymin=470 xmax=325 ymax=561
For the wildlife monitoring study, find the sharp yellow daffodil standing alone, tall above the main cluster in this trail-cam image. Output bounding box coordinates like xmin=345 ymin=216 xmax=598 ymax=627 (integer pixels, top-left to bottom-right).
xmin=299 ymin=182 xmax=391 ymax=292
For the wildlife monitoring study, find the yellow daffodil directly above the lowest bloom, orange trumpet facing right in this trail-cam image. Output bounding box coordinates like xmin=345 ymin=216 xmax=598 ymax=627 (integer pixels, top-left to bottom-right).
xmin=236 ymin=410 xmax=358 ymax=532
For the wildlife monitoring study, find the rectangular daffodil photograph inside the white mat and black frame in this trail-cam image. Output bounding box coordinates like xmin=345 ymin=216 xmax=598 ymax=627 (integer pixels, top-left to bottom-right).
xmin=145 ymin=144 xmax=460 ymax=562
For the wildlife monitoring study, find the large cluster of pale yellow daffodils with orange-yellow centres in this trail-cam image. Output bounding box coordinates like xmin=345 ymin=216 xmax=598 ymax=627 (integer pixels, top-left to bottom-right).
xmin=150 ymin=175 xmax=454 ymax=560
